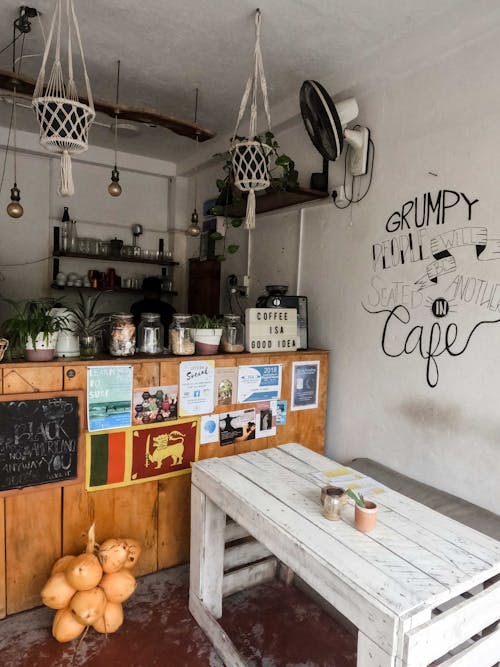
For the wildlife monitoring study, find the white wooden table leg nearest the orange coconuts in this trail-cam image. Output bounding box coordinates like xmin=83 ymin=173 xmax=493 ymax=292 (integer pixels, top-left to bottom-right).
xmin=189 ymin=484 xmax=226 ymax=618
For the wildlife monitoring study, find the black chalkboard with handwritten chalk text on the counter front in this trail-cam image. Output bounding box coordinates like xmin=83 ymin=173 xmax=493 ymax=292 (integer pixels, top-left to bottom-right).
xmin=0 ymin=394 xmax=80 ymax=492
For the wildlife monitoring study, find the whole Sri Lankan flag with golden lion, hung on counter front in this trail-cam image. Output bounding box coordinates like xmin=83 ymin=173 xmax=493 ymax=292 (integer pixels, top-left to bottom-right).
xmin=85 ymin=418 xmax=199 ymax=491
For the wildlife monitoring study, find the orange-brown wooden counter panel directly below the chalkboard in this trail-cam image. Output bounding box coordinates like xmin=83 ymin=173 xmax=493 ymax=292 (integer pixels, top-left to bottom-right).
xmin=5 ymin=489 xmax=61 ymax=614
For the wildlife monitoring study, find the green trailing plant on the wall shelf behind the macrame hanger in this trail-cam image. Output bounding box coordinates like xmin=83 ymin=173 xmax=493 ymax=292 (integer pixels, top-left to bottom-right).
xmin=210 ymin=130 xmax=298 ymax=262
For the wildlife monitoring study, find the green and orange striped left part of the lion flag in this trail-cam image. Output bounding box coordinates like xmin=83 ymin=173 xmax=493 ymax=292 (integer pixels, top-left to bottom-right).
xmin=86 ymin=431 xmax=127 ymax=491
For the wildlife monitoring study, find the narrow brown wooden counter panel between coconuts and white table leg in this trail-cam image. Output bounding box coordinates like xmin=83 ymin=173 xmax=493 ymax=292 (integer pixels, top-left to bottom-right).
xmin=158 ymin=475 xmax=191 ymax=569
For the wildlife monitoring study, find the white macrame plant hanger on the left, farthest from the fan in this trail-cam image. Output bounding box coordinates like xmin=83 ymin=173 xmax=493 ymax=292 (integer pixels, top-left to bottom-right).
xmin=32 ymin=0 xmax=95 ymax=196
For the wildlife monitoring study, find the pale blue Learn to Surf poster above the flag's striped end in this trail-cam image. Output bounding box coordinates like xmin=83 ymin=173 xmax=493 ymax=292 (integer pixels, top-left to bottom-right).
xmin=87 ymin=365 xmax=133 ymax=431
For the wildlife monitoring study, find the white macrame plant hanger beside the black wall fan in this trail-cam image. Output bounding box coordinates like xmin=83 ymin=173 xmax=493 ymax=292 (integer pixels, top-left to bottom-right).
xmin=231 ymin=9 xmax=272 ymax=229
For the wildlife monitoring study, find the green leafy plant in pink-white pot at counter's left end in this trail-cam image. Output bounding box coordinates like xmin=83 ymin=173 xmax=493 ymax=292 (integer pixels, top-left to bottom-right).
xmin=1 ymin=299 xmax=68 ymax=357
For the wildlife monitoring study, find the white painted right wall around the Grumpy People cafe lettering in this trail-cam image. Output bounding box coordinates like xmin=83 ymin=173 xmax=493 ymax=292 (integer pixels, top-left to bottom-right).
xmin=193 ymin=22 xmax=500 ymax=511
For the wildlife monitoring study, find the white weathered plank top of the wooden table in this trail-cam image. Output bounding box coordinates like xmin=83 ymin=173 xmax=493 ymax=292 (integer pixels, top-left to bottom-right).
xmin=193 ymin=443 xmax=500 ymax=618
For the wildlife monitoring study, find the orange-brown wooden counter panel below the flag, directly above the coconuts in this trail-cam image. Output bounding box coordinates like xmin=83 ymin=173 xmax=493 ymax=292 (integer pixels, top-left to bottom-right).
xmin=63 ymin=482 xmax=158 ymax=575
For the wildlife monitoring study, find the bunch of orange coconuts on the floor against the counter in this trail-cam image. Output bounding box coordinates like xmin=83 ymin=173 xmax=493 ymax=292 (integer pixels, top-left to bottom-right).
xmin=41 ymin=524 xmax=141 ymax=642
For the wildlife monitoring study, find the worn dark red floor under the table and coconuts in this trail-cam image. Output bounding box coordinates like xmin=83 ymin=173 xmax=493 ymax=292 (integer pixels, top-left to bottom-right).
xmin=0 ymin=566 xmax=356 ymax=667
